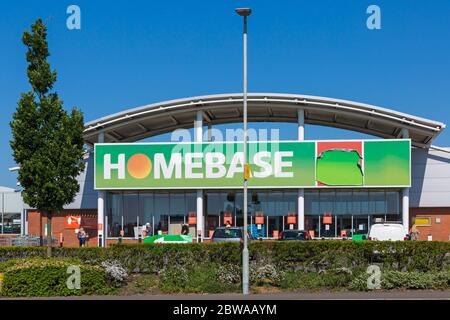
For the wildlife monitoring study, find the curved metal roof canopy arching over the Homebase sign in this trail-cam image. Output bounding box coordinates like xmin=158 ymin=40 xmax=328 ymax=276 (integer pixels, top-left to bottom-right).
xmin=84 ymin=93 xmax=445 ymax=147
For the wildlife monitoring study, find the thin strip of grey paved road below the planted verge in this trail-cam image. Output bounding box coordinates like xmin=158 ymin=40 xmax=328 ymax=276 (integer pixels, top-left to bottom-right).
xmin=6 ymin=290 xmax=450 ymax=301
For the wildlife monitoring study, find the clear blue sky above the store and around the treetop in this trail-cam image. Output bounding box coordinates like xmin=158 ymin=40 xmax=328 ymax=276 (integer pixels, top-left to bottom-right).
xmin=0 ymin=0 xmax=450 ymax=187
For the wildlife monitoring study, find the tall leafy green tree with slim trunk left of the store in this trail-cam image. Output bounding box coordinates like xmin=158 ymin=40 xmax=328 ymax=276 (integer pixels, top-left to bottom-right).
xmin=10 ymin=19 xmax=84 ymax=257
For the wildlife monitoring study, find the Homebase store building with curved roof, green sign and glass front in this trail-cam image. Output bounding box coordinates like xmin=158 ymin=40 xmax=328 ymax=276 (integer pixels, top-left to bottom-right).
xmin=22 ymin=93 xmax=450 ymax=246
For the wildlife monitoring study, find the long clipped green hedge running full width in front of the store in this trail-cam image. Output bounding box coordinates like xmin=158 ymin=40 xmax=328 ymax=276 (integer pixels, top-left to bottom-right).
xmin=0 ymin=240 xmax=450 ymax=273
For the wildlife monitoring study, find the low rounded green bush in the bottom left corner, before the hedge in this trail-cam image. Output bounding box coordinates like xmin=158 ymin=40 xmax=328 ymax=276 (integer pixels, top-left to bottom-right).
xmin=1 ymin=258 xmax=112 ymax=297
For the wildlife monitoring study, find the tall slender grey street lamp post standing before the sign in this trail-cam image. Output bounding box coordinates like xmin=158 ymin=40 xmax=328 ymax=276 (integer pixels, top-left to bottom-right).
xmin=236 ymin=8 xmax=252 ymax=295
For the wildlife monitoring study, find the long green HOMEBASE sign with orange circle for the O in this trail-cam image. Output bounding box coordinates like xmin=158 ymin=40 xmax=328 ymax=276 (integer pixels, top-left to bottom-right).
xmin=94 ymin=139 xmax=411 ymax=189
